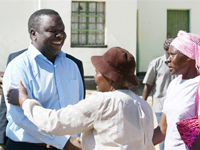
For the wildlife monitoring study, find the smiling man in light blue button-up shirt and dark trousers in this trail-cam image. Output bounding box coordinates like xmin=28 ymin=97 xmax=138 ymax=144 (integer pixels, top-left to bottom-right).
xmin=3 ymin=9 xmax=84 ymax=150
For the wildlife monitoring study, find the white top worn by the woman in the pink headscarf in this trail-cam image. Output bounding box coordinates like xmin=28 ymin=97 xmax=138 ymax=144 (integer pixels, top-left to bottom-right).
xmin=163 ymin=76 xmax=200 ymax=150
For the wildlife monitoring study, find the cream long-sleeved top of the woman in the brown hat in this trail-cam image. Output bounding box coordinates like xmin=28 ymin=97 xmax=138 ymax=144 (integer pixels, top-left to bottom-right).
xmin=23 ymin=90 xmax=155 ymax=150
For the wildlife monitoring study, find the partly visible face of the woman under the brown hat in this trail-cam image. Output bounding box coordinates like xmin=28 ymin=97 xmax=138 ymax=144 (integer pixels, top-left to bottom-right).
xmin=94 ymin=70 xmax=111 ymax=92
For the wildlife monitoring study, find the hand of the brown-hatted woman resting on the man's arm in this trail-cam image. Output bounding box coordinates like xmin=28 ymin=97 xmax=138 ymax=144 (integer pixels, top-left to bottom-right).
xmin=6 ymin=81 xmax=29 ymax=108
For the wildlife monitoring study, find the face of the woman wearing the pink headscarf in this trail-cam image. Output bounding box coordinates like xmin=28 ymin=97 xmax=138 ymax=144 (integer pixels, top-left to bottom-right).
xmin=167 ymin=46 xmax=190 ymax=75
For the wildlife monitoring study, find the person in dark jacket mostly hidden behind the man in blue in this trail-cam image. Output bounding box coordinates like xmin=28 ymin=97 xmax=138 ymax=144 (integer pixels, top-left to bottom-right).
xmin=0 ymin=49 xmax=85 ymax=150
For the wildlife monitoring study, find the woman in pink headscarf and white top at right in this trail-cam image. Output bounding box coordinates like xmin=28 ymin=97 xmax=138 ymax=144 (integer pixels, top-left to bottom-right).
xmin=153 ymin=31 xmax=200 ymax=150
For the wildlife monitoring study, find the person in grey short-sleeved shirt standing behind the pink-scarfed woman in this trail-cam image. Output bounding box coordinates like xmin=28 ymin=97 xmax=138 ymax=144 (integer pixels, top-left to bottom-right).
xmin=142 ymin=38 xmax=175 ymax=150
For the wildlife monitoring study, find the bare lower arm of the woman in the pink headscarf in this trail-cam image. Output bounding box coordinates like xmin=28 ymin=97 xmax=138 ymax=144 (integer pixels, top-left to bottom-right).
xmin=152 ymin=113 xmax=167 ymax=145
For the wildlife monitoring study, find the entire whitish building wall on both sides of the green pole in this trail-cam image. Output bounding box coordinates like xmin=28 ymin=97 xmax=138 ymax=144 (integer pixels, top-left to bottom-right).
xmin=0 ymin=0 xmax=200 ymax=76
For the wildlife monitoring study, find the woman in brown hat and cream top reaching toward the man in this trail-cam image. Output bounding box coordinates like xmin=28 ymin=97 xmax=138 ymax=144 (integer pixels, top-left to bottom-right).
xmin=7 ymin=47 xmax=155 ymax=150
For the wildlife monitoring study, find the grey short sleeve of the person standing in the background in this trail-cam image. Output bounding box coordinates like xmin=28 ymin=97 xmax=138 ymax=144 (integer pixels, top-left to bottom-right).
xmin=143 ymin=60 xmax=157 ymax=86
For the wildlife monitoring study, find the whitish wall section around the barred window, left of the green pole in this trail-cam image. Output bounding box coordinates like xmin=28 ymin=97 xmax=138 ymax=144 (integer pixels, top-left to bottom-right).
xmin=0 ymin=0 xmax=137 ymax=76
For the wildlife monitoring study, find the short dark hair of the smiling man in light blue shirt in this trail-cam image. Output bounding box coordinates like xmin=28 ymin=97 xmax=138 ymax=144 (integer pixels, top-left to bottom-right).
xmin=28 ymin=9 xmax=59 ymax=33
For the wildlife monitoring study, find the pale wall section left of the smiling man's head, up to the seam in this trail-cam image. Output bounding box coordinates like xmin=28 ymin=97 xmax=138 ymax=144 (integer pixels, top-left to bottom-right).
xmin=0 ymin=0 xmax=37 ymax=71
